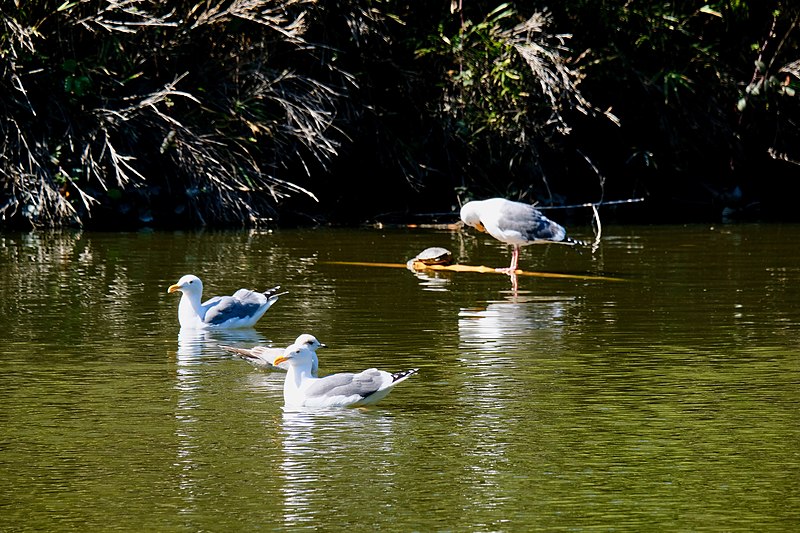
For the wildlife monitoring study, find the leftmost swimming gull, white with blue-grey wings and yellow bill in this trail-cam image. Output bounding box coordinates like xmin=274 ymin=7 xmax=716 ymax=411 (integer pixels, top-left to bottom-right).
xmin=167 ymin=274 xmax=286 ymax=329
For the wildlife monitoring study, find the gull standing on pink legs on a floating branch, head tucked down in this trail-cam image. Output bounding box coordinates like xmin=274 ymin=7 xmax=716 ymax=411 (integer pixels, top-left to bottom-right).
xmin=461 ymin=198 xmax=584 ymax=274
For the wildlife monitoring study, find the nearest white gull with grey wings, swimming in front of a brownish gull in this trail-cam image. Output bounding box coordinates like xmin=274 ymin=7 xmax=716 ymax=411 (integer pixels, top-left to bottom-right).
xmin=273 ymin=344 xmax=419 ymax=408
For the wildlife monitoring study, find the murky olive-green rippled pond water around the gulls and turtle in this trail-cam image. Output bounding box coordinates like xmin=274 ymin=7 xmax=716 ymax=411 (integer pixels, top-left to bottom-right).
xmin=0 ymin=225 xmax=800 ymax=532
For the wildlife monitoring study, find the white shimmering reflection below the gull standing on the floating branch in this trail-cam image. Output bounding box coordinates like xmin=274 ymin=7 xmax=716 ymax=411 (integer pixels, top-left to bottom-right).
xmin=456 ymin=291 xmax=575 ymax=507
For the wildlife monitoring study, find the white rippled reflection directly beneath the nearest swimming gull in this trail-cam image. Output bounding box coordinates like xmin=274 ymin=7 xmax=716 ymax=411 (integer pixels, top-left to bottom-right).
xmin=279 ymin=408 xmax=398 ymax=529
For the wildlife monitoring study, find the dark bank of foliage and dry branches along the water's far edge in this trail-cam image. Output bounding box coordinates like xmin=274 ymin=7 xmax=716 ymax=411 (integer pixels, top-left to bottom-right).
xmin=0 ymin=0 xmax=800 ymax=226
